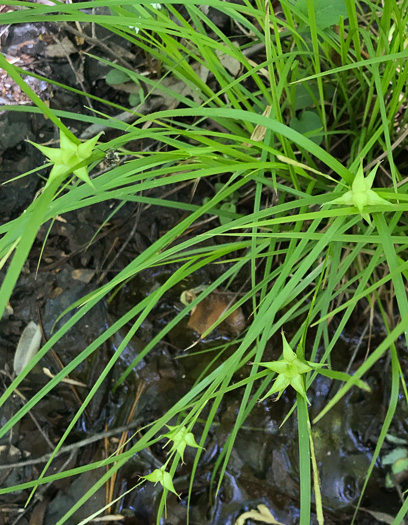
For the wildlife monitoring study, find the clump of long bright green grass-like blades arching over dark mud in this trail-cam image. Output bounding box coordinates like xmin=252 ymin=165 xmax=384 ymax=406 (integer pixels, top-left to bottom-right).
xmin=0 ymin=0 xmax=408 ymax=525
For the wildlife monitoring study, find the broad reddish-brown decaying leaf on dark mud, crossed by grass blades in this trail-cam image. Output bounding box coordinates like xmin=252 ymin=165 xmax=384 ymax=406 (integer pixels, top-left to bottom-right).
xmin=184 ymin=290 xmax=245 ymax=336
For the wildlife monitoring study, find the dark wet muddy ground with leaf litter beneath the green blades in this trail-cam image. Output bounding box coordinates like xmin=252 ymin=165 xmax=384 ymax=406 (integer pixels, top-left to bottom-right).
xmin=0 ymin=11 xmax=408 ymax=525
